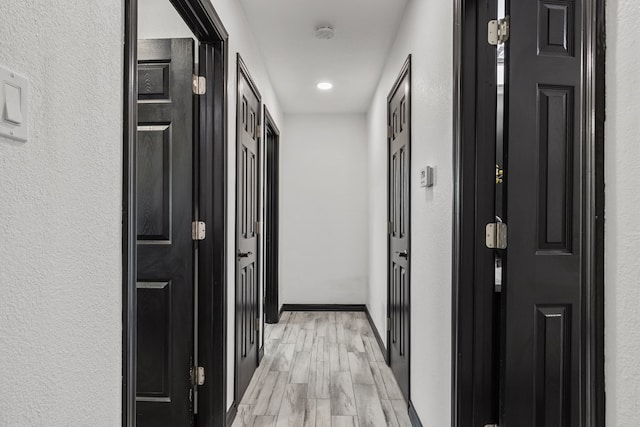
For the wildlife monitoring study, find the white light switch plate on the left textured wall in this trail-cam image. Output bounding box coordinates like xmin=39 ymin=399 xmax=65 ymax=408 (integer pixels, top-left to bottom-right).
xmin=0 ymin=67 xmax=29 ymax=142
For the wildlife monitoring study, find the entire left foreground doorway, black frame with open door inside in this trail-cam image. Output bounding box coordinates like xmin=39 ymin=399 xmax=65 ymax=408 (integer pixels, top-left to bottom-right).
xmin=123 ymin=0 xmax=228 ymax=426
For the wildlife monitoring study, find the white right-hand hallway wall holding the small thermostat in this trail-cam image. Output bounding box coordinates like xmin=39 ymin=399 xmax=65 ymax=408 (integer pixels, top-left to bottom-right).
xmin=367 ymin=0 xmax=453 ymax=426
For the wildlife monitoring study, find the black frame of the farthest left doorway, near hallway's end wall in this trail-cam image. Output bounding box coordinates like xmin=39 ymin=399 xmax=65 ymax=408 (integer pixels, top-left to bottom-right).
xmin=262 ymin=105 xmax=280 ymax=324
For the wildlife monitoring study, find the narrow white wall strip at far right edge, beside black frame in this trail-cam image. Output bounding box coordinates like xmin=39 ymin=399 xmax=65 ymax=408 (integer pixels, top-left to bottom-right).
xmin=605 ymin=0 xmax=640 ymax=427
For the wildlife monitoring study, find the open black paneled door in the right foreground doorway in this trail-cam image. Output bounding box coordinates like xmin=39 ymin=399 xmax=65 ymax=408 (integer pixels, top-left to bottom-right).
xmin=500 ymin=0 xmax=588 ymax=427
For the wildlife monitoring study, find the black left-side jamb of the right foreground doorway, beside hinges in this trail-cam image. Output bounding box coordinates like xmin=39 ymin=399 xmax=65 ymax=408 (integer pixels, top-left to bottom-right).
xmin=451 ymin=0 xmax=497 ymax=427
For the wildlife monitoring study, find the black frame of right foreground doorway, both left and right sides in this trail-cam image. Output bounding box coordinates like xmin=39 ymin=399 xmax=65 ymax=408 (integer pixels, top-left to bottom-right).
xmin=451 ymin=0 xmax=606 ymax=427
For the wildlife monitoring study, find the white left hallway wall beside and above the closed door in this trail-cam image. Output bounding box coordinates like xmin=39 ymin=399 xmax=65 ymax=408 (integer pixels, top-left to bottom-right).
xmin=206 ymin=0 xmax=286 ymax=407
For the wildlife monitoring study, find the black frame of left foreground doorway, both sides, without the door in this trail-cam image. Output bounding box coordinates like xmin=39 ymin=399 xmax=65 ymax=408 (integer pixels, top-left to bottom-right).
xmin=122 ymin=0 xmax=229 ymax=427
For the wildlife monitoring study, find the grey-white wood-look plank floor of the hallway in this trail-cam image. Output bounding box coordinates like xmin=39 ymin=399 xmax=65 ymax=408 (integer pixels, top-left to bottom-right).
xmin=233 ymin=312 xmax=411 ymax=427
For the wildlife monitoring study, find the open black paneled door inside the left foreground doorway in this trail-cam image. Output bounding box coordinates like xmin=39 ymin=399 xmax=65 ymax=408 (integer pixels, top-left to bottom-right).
xmin=136 ymin=39 xmax=194 ymax=427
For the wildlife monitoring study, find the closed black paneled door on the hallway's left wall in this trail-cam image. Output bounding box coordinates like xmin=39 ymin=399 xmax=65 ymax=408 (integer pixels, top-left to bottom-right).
xmin=235 ymin=56 xmax=260 ymax=402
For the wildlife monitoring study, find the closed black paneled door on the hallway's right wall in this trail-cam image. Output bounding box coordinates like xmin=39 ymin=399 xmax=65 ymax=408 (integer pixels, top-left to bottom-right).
xmin=387 ymin=58 xmax=411 ymax=401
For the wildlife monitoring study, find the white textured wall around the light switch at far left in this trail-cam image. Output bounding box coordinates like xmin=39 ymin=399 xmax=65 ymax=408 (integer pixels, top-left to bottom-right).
xmin=0 ymin=0 xmax=123 ymax=426
